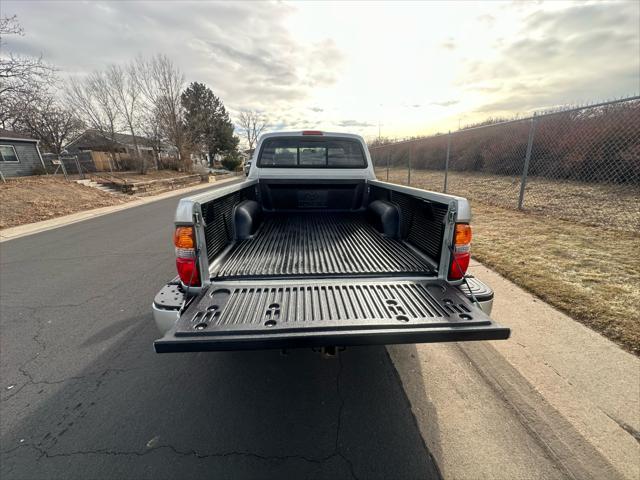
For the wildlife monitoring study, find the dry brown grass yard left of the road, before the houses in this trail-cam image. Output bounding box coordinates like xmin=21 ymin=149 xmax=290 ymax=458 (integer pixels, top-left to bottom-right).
xmin=0 ymin=176 xmax=135 ymax=229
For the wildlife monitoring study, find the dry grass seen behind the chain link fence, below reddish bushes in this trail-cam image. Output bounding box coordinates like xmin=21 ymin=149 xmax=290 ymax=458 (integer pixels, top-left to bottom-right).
xmin=377 ymin=169 xmax=640 ymax=231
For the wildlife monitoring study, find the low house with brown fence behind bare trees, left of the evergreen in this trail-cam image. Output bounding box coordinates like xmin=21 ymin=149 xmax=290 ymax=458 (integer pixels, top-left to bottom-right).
xmin=65 ymin=129 xmax=167 ymax=170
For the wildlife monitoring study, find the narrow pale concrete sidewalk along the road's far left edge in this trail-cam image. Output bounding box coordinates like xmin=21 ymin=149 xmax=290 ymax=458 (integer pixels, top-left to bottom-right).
xmin=0 ymin=177 xmax=244 ymax=243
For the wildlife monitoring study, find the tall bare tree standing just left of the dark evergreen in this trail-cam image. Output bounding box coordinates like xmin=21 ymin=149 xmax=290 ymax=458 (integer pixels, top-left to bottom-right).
xmin=135 ymin=54 xmax=186 ymax=169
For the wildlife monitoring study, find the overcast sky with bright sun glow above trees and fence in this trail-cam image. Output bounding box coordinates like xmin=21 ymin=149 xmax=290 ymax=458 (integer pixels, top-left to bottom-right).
xmin=5 ymin=0 xmax=640 ymax=137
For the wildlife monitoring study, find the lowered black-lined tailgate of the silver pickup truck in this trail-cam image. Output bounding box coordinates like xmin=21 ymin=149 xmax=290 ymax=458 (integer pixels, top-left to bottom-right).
xmin=154 ymin=279 xmax=510 ymax=353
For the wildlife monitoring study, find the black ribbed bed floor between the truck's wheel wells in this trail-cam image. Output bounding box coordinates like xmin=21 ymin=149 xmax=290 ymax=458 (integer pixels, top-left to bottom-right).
xmin=217 ymin=213 xmax=431 ymax=277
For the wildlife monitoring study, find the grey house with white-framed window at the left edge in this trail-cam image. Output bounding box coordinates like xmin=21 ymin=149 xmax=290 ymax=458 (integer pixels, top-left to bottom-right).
xmin=0 ymin=129 xmax=44 ymax=177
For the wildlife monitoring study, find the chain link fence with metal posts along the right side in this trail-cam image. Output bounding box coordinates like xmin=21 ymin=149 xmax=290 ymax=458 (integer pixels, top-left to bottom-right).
xmin=370 ymin=97 xmax=640 ymax=231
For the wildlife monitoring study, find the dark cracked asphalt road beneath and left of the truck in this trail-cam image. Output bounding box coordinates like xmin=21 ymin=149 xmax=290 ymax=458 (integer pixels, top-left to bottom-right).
xmin=0 ymin=182 xmax=439 ymax=480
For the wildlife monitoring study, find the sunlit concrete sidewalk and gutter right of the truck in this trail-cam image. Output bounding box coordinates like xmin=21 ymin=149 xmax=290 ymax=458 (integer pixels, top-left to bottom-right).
xmin=389 ymin=262 xmax=640 ymax=480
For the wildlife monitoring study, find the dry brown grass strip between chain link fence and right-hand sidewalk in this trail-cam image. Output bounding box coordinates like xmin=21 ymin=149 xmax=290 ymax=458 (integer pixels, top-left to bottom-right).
xmin=472 ymin=202 xmax=640 ymax=355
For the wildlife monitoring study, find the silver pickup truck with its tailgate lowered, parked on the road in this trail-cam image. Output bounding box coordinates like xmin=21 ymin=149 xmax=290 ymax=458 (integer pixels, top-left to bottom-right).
xmin=153 ymin=131 xmax=510 ymax=353
